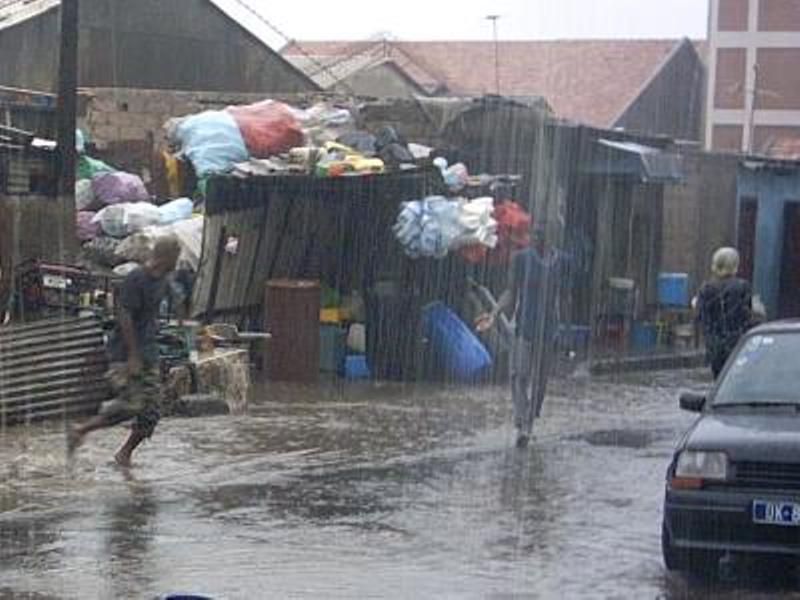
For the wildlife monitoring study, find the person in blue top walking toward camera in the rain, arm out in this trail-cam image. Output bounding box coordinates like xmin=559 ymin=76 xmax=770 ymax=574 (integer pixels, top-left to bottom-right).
xmin=476 ymin=228 xmax=560 ymax=448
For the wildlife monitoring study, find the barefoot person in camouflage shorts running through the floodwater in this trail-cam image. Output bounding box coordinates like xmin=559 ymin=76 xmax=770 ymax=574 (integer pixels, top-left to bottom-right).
xmin=67 ymin=236 xmax=180 ymax=467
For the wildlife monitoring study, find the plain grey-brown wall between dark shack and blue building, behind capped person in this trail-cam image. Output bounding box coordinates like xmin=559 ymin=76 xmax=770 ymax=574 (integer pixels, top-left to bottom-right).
xmin=662 ymin=150 xmax=739 ymax=290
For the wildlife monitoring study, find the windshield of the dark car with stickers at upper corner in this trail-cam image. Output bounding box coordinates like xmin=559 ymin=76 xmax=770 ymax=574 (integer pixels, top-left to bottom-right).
xmin=714 ymin=333 xmax=800 ymax=406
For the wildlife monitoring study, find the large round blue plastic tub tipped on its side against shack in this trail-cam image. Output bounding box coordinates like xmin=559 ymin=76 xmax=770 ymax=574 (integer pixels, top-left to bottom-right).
xmin=422 ymin=302 xmax=492 ymax=380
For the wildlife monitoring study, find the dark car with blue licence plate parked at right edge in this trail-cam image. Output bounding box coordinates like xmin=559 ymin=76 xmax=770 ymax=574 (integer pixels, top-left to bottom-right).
xmin=662 ymin=321 xmax=800 ymax=570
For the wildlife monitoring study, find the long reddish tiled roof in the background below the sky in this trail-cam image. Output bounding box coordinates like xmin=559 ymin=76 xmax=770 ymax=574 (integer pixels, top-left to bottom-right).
xmin=281 ymin=39 xmax=704 ymax=127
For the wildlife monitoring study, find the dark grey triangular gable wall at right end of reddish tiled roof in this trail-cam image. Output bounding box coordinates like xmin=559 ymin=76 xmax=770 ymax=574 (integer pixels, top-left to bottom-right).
xmin=612 ymin=40 xmax=705 ymax=140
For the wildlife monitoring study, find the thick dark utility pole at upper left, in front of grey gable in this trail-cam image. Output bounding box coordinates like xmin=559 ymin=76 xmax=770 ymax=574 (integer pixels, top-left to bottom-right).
xmin=56 ymin=0 xmax=79 ymax=196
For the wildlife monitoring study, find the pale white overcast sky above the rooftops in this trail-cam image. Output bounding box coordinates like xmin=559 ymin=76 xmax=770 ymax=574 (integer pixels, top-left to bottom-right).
xmin=244 ymin=0 xmax=708 ymax=47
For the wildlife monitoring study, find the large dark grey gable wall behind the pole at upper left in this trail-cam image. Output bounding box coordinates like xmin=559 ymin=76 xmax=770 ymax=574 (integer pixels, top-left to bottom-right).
xmin=0 ymin=0 xmax=317 ymax=93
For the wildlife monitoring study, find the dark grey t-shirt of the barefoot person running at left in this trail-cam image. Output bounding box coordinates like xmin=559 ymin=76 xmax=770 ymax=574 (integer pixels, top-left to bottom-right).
xmin=109 ymin=268 xmax=169 ymax=364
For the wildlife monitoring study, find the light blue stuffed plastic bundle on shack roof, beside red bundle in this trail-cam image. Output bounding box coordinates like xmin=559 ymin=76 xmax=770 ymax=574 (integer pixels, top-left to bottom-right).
xmin=174 ymin=111 xmax=250 ymax=179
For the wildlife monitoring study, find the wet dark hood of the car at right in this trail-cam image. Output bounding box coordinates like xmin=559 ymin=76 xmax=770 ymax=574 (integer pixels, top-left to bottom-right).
xmin=686 ymin=409 xmax=800 ymax=463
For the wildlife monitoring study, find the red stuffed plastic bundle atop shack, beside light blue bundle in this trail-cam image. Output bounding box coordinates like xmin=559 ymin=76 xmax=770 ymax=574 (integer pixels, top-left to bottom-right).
xmin=225 ymin=100 xmax=303 ymax=158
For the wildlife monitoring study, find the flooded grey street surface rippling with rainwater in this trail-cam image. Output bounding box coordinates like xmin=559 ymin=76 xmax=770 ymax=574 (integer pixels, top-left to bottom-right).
xmin=0 ymin=371 xmax=800 ymax=600
